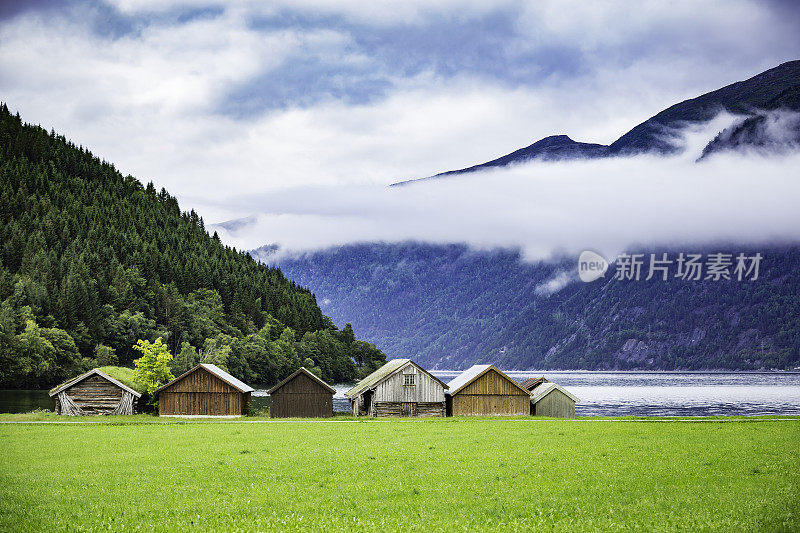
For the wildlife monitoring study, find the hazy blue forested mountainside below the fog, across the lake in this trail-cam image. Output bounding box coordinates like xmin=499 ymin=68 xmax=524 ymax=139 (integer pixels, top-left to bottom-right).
xmin=270 ymin=243 xmax=800 ymax=370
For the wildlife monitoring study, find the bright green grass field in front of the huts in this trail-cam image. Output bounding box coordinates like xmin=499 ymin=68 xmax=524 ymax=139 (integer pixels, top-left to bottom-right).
xmin=0 ymin=417 xmax=800 ymax=532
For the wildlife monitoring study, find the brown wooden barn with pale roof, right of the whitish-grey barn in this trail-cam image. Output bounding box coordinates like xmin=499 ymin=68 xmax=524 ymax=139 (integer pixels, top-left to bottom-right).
xmin=446 ymin=365 xmax=531 ymax=416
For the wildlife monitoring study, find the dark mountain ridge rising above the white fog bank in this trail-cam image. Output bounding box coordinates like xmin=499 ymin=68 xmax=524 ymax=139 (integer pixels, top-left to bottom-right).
xmin=392 ymin=60 xmax=800 ymax=186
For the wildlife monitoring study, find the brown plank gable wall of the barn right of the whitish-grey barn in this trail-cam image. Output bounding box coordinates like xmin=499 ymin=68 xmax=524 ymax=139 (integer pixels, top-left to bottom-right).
xmin=451 ymin=370 xmax=530 ymax=416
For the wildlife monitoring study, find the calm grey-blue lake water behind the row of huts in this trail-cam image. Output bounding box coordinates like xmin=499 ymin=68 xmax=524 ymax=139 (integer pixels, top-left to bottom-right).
xmin=0 ymin=371 xmax=800 ymax=416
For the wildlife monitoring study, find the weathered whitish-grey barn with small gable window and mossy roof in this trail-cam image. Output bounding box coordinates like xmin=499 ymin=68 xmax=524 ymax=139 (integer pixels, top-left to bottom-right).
xmin=345 ymin=359 xmax=447 ymax=416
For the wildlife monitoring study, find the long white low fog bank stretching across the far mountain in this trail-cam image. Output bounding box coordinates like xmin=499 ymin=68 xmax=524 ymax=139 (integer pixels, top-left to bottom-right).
xmin=215 ymin=115 xmax=800 ymax=260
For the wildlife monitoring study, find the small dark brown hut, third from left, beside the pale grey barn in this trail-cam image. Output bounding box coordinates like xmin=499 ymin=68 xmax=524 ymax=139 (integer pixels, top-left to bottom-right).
xmin=267 ymin=367 xmax=336 ymax=418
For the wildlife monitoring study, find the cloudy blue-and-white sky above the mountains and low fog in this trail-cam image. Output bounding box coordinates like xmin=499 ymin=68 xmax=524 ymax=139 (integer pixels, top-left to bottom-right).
xmin=0 ymin=0 xmax=800 ymax=254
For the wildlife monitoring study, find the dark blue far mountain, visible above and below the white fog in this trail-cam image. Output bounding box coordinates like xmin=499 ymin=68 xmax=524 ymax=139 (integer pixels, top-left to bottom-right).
xmin=248 ymin=61 xmax=800 ymax=370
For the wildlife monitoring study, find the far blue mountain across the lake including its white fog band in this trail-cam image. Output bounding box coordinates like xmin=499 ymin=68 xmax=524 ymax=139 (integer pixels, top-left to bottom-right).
xmin=218 ymin=62 xmax=800 ymax=370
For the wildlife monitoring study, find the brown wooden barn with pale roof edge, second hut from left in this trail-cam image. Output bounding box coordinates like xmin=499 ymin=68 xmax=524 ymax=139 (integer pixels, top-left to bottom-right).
xmin=156 ymin=363 xmax=253 ymax=416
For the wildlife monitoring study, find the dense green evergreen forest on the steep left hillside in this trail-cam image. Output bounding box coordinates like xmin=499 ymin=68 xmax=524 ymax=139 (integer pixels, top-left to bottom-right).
xmin=0 ymin=104 xmax=385 ymax=388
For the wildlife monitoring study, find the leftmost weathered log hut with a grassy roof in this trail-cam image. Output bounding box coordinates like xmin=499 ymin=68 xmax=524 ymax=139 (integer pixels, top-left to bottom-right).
xmin=50 ymin=368 xmax=141 ymax=416
